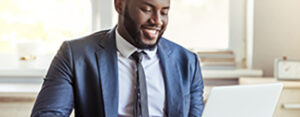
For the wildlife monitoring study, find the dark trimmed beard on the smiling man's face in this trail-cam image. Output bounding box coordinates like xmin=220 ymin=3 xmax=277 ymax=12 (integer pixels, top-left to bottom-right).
xmin=124 ymin=5 xmax=163 ymax=50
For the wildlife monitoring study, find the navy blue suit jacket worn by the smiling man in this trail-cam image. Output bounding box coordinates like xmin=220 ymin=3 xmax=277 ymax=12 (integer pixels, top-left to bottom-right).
xmin=31 ymin=29 xmax=204 ymax=117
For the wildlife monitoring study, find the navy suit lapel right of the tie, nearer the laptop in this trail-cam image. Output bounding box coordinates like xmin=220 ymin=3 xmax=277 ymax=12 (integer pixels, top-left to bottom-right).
xmin=158 ymin=39 xmax=183 ymax=117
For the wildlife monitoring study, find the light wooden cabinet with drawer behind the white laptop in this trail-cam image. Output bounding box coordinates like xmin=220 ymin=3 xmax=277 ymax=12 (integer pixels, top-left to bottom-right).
xmin=239 ymin=77 xmax=300 ymax=117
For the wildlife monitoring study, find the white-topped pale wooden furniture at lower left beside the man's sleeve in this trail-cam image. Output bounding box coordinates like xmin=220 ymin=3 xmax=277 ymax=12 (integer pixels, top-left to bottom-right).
xmin=0 ymin=83 xmax=41 ymax=117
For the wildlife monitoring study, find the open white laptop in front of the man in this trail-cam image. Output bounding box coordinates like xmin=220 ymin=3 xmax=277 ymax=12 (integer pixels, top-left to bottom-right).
xmin=202 ymin=83 xmax=283 ymax=117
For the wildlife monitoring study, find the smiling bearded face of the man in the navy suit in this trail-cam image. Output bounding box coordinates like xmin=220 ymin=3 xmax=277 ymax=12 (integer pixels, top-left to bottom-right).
xmin=116 ymin=0 xmax=170 ymax=49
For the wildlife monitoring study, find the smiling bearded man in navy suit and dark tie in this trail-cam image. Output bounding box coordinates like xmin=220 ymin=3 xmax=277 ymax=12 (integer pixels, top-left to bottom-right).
xmin=31 ymin=0 xmax=203 ymax=117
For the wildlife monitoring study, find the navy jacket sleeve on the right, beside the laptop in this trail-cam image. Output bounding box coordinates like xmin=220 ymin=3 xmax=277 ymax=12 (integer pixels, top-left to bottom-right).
xmin=189 ymin=54 xmax=204 ymax=117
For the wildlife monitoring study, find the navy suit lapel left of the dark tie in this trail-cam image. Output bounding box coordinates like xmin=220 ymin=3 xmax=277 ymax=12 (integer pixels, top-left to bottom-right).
xmin=96 ymin=29 xmax=119 ymax=117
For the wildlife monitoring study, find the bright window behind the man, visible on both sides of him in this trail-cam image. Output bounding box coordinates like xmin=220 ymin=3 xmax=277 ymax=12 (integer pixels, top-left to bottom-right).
xmin=0 ymin=0 xmax=245 ymax=68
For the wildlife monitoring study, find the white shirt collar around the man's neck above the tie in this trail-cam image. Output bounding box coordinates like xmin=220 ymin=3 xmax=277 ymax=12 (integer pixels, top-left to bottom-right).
xmin=115 ymin=28 xmax=157 ymax=59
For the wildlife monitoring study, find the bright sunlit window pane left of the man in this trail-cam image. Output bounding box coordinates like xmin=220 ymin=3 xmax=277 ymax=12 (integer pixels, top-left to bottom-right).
xmin=0 ymin=0 xmax=92 ymax=68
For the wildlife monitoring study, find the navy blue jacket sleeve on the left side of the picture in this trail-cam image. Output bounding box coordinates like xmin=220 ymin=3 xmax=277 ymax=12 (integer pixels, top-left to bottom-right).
xmin=31 ymin=42 xmax=74 ymax=117
